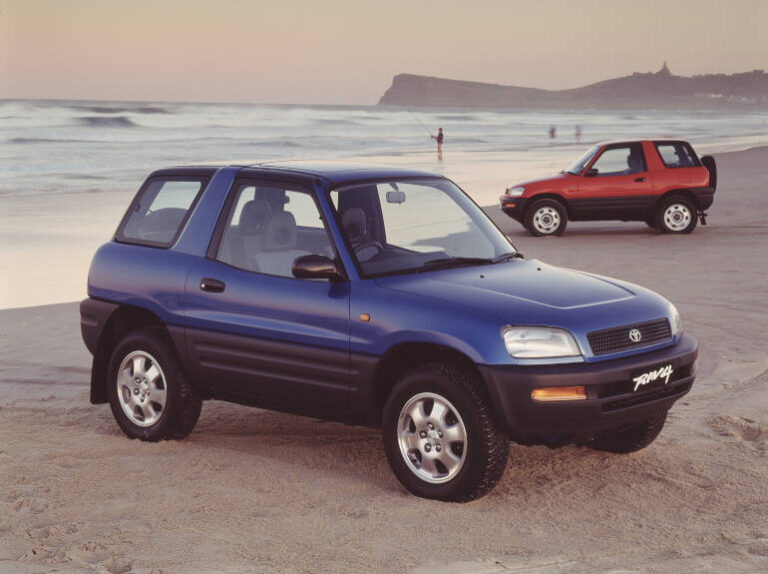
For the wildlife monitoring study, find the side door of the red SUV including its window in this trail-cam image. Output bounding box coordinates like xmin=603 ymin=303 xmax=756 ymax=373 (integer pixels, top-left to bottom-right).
xmin=573 ymin=142 xmax=653 ymax=220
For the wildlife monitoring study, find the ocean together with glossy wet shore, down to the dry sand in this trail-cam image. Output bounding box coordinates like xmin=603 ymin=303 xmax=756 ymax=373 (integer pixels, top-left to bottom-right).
xmin=0 ymin=100 xmax=768 ymax=309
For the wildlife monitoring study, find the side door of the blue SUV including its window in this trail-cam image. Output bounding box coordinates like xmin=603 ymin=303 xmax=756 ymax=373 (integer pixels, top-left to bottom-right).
xmin=185 ymin=180 xmax=349 ymax=411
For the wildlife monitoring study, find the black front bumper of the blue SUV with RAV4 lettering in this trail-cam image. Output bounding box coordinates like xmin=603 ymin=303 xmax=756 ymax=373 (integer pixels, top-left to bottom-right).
xmin=480 ymin=336 xmax=698 ymax=438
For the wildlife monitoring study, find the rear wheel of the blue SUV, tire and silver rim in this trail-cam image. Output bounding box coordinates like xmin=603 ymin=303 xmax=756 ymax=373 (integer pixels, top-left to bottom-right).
xmin=107 ymin=329 xmax=202 ymax=441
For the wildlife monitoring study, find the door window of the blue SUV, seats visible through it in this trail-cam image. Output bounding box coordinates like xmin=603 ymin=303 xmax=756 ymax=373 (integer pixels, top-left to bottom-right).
xmin=216 ymin=183 xmax=334 ymax=278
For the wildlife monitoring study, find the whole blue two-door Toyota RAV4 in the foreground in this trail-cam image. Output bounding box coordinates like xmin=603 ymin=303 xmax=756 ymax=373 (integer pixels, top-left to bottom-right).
xmin=81 ymin=161 xmax=697 ymax=501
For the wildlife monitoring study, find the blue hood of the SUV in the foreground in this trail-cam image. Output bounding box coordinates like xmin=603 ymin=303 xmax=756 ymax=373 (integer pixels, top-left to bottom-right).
xmin=376 ymin=259 xmax=667 ymax=331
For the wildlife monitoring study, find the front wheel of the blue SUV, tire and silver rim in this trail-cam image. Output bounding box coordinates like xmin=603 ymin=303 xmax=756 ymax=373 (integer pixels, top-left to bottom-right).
xmin=382 ymin=363 xmax=509 ymax=502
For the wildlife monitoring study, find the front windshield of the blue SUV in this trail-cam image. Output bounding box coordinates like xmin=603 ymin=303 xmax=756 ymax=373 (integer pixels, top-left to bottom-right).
xmin=330 ymin=179 xmax=520 ymax=277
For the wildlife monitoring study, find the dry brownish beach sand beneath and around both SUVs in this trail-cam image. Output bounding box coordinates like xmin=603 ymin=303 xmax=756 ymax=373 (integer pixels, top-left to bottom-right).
xmin=0 ymin=148 xmax=768 ymax=574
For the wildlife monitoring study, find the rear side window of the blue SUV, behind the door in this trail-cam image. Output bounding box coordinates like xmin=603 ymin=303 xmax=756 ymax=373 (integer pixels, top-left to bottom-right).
xmin=116 ymin=178 xmax=207 ymax=247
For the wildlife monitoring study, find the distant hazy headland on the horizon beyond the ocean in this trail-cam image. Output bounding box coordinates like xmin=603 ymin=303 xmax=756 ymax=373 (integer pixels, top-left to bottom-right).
xmin=379 ymin=63 xmax=768 ymax=110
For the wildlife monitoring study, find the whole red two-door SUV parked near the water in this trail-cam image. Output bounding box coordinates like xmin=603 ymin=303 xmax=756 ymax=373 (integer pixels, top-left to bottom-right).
xmin=500 ymin=140 xmax=717 ymax=236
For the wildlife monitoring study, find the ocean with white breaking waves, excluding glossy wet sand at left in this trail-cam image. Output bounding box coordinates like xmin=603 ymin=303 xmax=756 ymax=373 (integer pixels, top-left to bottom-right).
xmin=0 ymin=100 xmax=768 ymax=204
